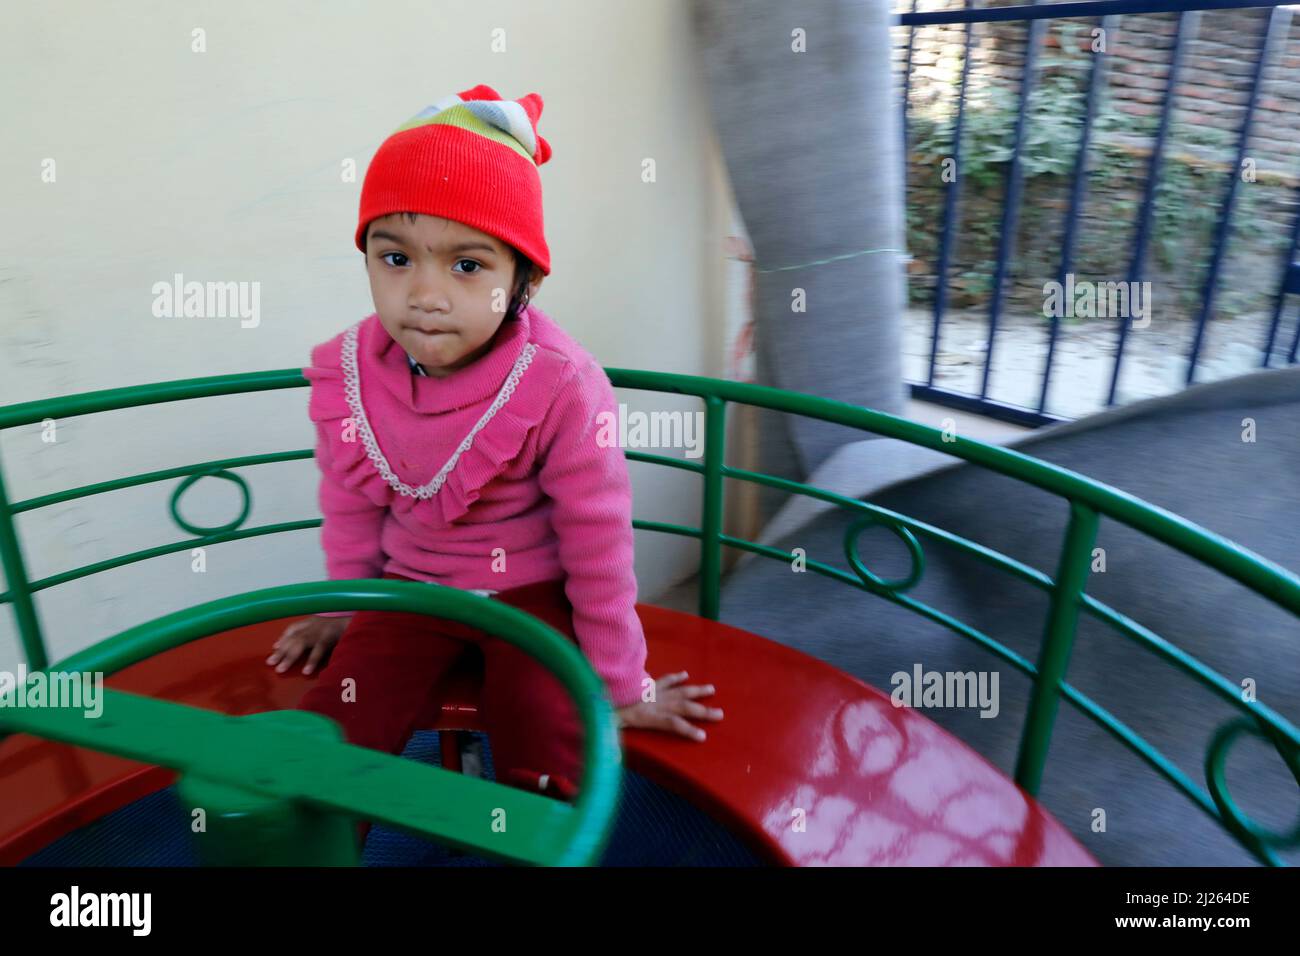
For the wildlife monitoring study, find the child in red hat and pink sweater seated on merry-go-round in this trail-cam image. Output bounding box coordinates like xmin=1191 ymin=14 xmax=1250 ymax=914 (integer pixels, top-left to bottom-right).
xmin=267 ymin=86 xmax=723 ymax=800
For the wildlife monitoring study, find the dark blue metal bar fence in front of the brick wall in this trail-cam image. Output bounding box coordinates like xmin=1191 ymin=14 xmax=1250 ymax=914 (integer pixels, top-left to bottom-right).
xmin=898 ymin=0 xmax=1300 ymax=425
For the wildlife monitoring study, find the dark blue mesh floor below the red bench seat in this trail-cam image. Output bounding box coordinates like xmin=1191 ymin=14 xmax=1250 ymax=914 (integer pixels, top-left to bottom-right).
xmin=20 ymin=731 xmax=762 ymax=866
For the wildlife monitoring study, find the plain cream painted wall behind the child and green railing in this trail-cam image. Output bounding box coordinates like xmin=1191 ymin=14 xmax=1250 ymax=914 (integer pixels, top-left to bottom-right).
xmin=0 ymin=0 xmax=732 ymax=667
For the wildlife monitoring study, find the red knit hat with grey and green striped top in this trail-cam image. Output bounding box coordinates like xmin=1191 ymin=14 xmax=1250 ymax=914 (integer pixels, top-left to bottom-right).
xmin=356 ymin=86 xmax=551 ymax=276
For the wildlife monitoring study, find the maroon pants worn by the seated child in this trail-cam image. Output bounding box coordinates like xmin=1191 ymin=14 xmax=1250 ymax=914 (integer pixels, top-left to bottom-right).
xmin=298 ymin=574 xmax=582 ymax=799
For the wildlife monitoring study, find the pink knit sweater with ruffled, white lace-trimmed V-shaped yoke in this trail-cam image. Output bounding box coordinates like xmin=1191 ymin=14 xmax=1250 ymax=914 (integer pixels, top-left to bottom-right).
xmin=303 ymin=304 xmax=650 ymax=706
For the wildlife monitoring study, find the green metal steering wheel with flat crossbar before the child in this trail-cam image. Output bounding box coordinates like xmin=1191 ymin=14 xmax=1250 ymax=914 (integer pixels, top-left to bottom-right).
xmin=0 ymin=579 xmax=621 ymax=865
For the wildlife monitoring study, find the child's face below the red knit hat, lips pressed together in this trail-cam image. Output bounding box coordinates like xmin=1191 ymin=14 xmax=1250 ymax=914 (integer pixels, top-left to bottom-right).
xmin=365 ymin=213 xmax=542 ymax=378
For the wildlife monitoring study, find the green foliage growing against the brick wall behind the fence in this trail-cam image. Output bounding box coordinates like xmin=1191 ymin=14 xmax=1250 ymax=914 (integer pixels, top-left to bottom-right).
xmin=907 ymin=21 xmax=1287 ymax=321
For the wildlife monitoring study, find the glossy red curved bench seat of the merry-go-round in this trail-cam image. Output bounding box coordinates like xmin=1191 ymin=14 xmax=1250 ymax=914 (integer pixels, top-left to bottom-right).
xmin=0 ymin=605 xmax=1096 ymax=866
